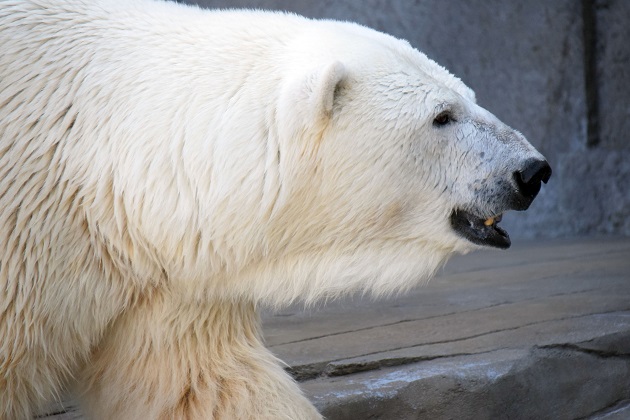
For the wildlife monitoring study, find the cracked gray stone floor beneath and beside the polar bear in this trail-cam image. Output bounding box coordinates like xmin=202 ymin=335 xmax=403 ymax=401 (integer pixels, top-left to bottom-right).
xmin=39 ymin=238 xmax=630 ymax=420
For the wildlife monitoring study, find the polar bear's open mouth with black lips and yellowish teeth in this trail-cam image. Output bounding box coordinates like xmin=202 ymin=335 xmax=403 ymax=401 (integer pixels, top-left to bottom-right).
xmin=451 ymin=210 xmax=511 ymax=249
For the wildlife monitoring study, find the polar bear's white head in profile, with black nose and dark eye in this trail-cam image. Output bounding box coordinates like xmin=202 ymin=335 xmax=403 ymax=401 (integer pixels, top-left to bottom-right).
xmin=260 ymin=23 xmax=551 ymax=300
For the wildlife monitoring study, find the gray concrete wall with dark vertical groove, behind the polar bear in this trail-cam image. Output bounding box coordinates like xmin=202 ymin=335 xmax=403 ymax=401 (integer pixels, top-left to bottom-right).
xmin=177 ymin=0 xmax=630 ymax=238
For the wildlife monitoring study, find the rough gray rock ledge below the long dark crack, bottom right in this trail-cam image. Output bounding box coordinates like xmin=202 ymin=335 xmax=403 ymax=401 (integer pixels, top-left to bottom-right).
xmin=305 ymin=336 xmax=630 ymax=419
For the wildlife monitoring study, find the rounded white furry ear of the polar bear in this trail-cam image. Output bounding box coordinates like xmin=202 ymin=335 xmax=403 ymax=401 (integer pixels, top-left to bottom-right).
xmin=279 ymin=61 xmax=346 ymax=135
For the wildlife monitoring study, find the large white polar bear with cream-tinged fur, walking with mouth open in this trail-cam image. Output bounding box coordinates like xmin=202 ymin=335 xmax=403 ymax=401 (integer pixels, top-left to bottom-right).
xmin=0 ymin=0 xmax=551 ymax=420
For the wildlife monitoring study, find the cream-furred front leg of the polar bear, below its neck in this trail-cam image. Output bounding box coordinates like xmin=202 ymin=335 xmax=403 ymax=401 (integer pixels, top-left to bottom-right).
xmin=81 ymin=296 xmax=322 ymax=420
